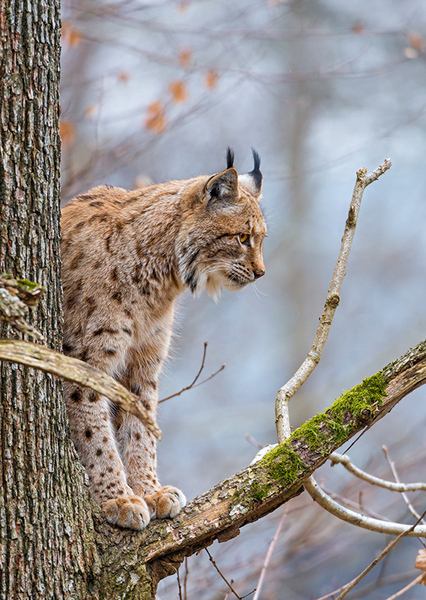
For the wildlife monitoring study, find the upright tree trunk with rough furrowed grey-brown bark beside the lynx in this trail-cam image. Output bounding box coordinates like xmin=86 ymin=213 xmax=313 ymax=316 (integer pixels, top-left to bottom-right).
xmin=0 ymin=0 xmax=98 ymax=600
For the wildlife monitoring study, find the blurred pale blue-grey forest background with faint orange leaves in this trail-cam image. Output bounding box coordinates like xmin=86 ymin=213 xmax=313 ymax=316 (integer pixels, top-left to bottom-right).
xmin=61 ymin=0 xmax=426 ymax=600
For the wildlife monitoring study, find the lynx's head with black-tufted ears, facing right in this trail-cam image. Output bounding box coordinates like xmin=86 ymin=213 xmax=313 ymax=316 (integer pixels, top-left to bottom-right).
xmin=178 ymin=148 xmax=266 ymax=296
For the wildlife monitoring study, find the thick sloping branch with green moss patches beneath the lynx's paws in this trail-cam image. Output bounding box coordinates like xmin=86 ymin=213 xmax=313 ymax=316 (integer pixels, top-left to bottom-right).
xmin=97 ymin=342 xmax=426 ymax=578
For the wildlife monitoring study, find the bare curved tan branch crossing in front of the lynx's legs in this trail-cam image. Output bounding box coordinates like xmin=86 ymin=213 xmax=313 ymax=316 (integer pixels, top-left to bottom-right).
xmin=0 ymin=340 xmax=161 ymax=439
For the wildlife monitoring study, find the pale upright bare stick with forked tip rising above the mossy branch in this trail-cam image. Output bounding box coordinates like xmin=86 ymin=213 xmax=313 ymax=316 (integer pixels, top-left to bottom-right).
xmin=275 ymin=158 xmax=391 ymax=443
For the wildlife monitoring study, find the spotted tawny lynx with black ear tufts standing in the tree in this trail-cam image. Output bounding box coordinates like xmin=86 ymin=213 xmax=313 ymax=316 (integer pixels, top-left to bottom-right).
xmin=62 ymin=149 xmax=266 ymax=530
